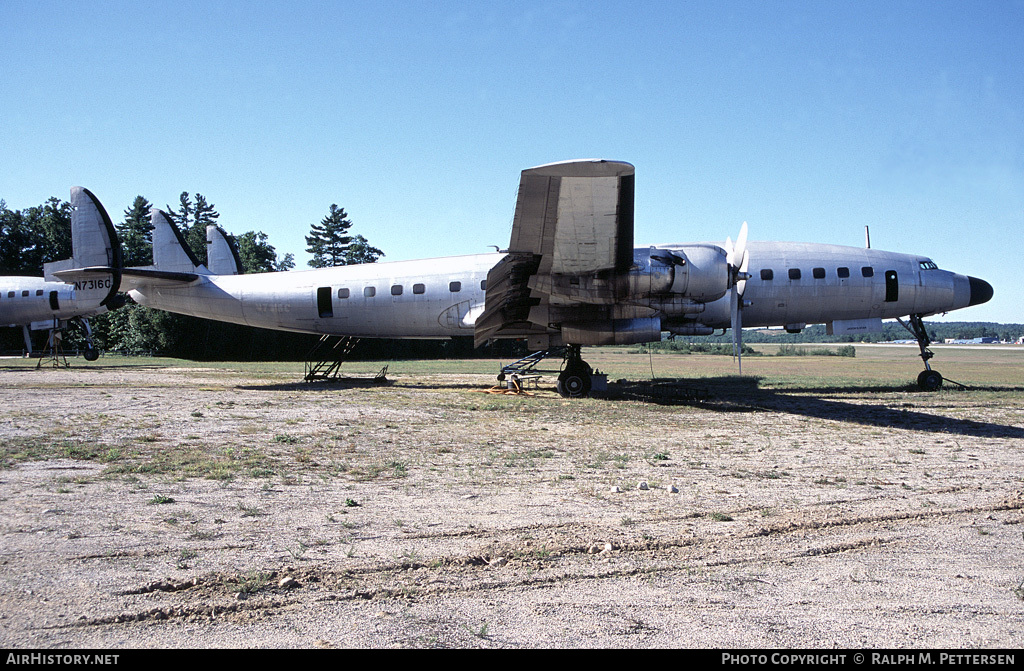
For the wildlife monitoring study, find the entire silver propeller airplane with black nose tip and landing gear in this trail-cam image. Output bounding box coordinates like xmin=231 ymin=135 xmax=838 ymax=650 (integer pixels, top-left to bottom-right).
xmin=105 ymin=160 xmax=992 ymax=396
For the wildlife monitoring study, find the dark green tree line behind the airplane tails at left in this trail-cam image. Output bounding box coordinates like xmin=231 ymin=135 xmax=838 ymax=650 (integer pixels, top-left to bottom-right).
xmin=0 ymin=192 xmax=384 ymax=361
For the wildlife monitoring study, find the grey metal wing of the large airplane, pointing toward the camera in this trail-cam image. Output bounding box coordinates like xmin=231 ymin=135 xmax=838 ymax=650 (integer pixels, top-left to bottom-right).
xmin=475 ymin=160 xmax=634 ymax=345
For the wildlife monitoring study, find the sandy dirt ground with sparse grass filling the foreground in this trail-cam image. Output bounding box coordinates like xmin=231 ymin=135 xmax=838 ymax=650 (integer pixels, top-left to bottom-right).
xmin=0 ymin=361 xmax=1024 ymax=648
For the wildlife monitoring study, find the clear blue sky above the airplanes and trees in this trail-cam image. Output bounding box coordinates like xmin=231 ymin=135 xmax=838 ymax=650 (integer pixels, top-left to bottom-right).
xmin=0 ymin=0 xmax=1024 ymax=322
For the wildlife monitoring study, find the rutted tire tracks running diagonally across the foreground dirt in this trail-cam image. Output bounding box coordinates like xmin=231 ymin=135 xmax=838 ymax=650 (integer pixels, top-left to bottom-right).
xmin=61 ymin=497 xmax=1024 ymax=628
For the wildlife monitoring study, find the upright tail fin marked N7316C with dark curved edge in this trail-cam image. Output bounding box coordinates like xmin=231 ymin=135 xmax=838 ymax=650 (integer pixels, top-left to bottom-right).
xmin=43 ymin=186 xmax=123 ymax=309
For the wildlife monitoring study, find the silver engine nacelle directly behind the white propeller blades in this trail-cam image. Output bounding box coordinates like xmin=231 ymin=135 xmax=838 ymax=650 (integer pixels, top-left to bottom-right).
xmin=630 ymin=245 xmax=729 ymax=302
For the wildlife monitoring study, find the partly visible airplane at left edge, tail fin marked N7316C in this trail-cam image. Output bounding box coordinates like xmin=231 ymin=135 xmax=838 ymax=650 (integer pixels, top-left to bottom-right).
xmin=0 ymin=186 xmax=124 ymax=361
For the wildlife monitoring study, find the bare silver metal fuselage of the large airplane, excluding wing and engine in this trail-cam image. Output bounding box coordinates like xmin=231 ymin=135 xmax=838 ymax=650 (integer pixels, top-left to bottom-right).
xmin=130 ymin=242 xmax=987 ymax=338
